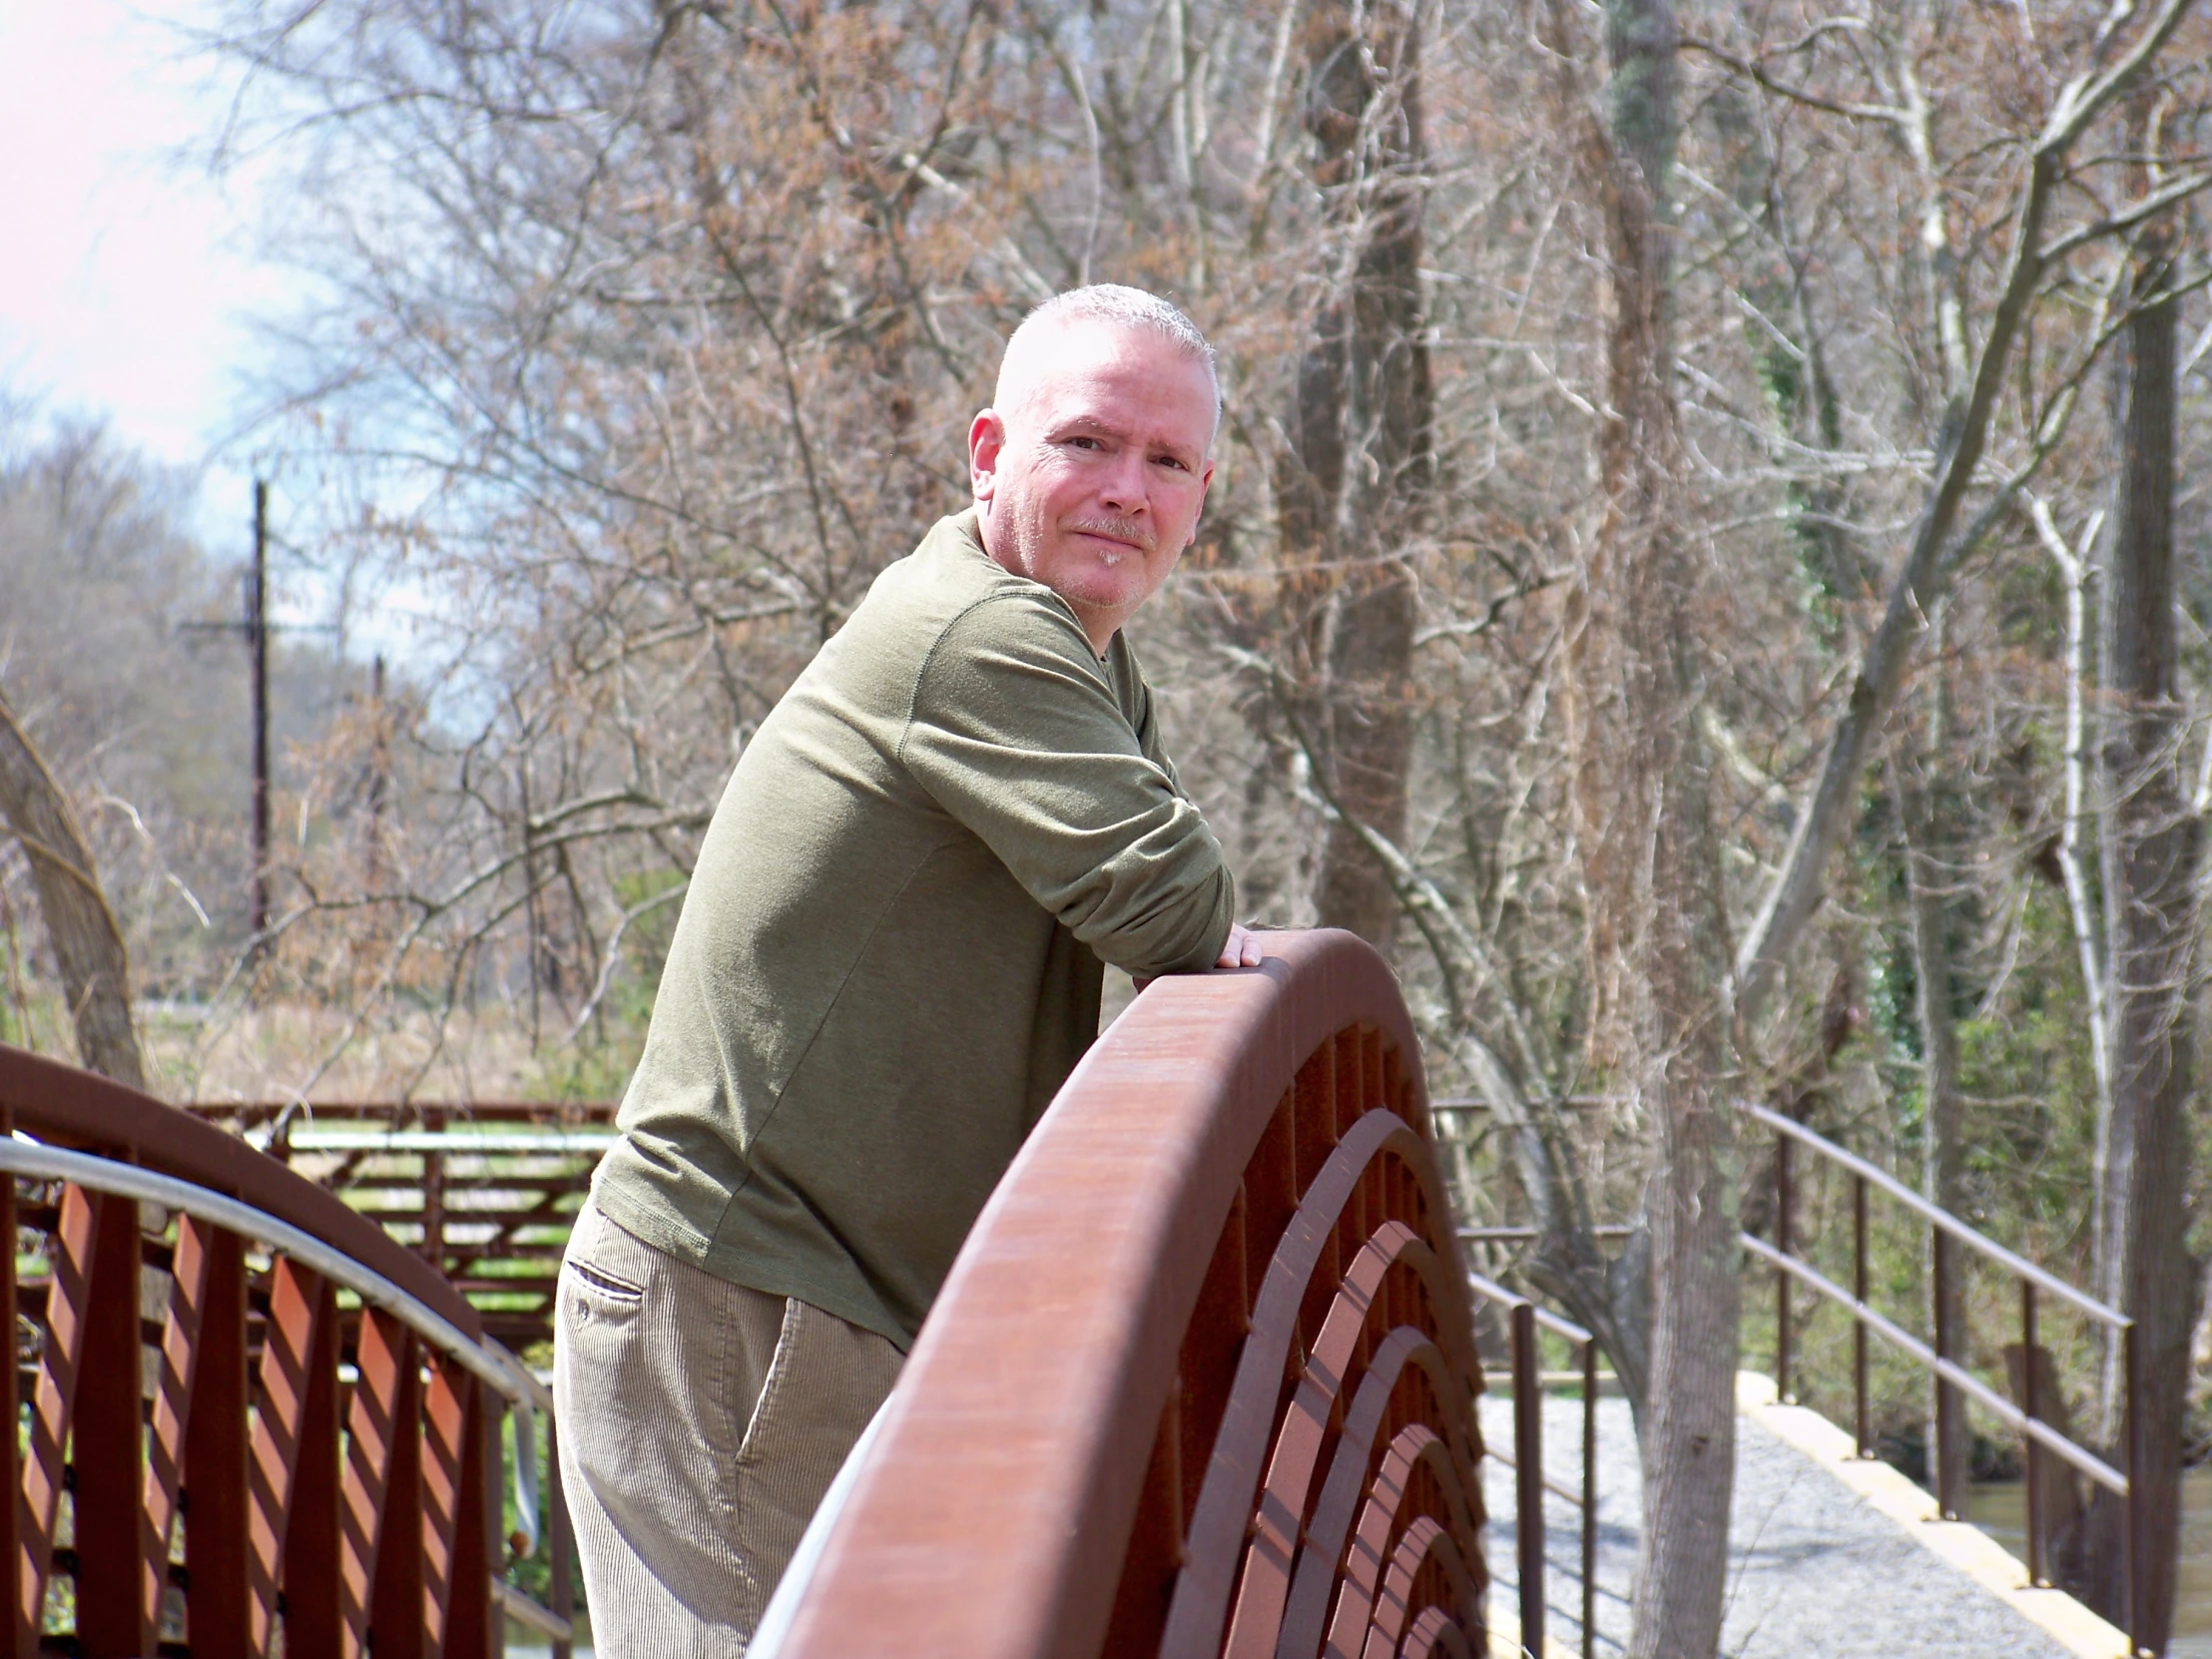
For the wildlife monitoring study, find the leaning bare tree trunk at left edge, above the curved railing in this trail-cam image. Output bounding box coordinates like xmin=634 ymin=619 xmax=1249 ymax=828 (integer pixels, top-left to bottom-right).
xmin=0 ymin=699 xmax=146 ymax=1088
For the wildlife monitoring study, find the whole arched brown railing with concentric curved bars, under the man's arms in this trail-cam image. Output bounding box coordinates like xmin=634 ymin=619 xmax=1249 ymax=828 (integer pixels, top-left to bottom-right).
xmin=759 ymin=931 xmax=1486 ymax=1659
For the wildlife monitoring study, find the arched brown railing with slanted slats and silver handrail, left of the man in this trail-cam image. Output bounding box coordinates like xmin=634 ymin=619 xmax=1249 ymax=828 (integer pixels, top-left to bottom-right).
xmin=0 ymin=1046 xmax=569 ymax=1659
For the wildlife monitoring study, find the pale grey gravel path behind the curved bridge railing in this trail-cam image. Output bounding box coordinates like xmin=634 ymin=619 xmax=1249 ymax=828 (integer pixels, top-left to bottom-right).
xmin=1482 ymin=1395 xmax=2070 ymax=1659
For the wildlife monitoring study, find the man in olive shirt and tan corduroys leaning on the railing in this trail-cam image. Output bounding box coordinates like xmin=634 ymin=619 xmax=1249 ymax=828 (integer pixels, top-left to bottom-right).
xmin=553 ymin=287 xmax=1261 ymax=1659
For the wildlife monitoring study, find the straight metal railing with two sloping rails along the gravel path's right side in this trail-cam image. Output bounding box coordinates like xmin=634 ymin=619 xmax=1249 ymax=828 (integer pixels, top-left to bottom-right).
xmin=1741 ymin=1102 xmax=2146 ymax=1648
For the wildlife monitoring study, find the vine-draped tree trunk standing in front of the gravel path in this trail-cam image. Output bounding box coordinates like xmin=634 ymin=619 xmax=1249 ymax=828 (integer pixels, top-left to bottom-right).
xmin=1566 ymin=0 xmax=1739 ymax=1659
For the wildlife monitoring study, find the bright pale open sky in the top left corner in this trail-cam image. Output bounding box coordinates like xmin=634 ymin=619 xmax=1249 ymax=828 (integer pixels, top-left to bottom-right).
xmin=0 ymin=0 xmax=298 ymax=555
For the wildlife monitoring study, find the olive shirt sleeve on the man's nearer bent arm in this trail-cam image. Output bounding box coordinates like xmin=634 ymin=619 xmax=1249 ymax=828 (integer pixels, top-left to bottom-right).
xmin=900 ymin=593 xmax=1237 ymax=975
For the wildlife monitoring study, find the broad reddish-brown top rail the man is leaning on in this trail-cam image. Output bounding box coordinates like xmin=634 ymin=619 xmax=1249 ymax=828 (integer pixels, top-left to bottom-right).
xmin=775 ymin=931 xmax=1471 ymax=1659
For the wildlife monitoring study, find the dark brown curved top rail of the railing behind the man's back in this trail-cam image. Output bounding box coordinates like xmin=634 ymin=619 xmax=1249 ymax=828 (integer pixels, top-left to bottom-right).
xmin=0 ymin=1042 xmax=484 ymax=1343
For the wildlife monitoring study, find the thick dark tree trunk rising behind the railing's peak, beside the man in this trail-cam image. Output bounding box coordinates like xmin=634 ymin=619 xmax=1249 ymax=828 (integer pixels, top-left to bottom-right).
xmin=1279 ymin=0 xmax=1435 ymax=955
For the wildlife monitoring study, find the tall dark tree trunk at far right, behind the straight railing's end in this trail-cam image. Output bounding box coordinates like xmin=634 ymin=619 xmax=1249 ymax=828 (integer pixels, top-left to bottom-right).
xmin=2086 ymin=230 xmax=2199 ymax=1652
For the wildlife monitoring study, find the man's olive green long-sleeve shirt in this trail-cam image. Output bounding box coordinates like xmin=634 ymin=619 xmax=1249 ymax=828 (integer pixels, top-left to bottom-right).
xmin=595 ymin=513 xmax=1235 ymax=1348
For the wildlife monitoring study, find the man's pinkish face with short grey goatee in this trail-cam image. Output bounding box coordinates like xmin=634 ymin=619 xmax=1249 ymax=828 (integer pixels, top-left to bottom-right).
xmin=969 ymin=318 xmax=1215 ymax=653
